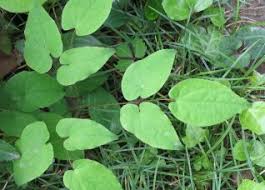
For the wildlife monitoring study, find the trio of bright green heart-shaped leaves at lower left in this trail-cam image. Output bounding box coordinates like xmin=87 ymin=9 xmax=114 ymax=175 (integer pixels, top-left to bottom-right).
xmin=13 ymin=118 xmax=121 ymax=190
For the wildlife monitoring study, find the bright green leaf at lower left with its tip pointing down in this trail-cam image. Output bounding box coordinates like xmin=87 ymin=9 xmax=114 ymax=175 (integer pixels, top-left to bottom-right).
xmin=13 ymin=122 xmax=53 ymax=186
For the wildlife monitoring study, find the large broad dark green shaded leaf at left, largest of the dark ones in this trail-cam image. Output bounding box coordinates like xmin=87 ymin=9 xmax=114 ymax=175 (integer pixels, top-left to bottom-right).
xmin=4 ymin=71 xmax=64 ymax=112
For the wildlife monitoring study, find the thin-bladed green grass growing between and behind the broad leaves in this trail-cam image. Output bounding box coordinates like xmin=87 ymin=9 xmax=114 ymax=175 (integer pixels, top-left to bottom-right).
xmin=0 ymin=1 xmax=265 ymax=190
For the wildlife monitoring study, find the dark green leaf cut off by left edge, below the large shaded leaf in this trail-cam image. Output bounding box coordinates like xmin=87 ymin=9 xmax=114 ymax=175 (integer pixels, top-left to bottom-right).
xmin=0 ymin=110 xmax=37 ymax=137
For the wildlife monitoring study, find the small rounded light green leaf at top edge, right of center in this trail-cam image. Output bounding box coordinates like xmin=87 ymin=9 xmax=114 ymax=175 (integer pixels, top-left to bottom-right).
xmin=162 ymin=0 xmax=192 ymax=21
